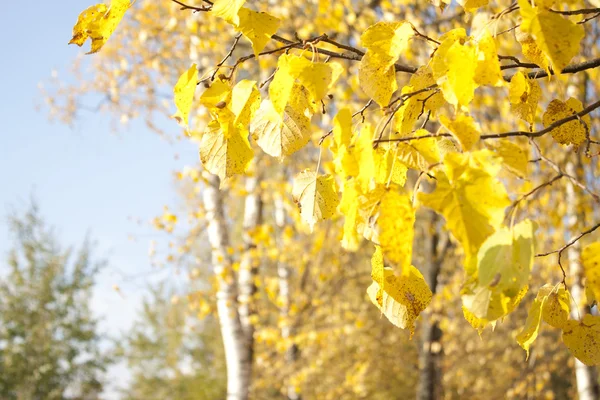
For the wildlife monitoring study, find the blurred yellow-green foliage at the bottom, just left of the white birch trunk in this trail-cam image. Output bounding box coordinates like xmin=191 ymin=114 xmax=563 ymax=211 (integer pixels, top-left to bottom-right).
xmin=122 ymin=285 xmax=225 ymax=400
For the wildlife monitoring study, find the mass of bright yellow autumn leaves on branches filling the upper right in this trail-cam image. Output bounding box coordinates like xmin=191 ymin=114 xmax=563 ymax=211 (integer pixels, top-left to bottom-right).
xmin=59 ymin=0 xmax=600 ymax=396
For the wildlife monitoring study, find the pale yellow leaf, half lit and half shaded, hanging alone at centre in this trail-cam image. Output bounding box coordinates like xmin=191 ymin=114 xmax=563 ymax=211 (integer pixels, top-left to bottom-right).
xmin=292 ymin=170 xmax=339 ymax=230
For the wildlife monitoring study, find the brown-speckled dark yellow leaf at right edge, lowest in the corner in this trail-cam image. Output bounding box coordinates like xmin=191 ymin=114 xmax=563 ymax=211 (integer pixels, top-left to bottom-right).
xmin=562 ymin=314 xmax=600 ymax=365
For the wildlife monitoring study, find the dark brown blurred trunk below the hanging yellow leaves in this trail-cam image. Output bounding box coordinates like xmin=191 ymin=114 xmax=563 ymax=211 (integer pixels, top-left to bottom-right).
xmin=417 ymin=212 xmax=447 ymax=400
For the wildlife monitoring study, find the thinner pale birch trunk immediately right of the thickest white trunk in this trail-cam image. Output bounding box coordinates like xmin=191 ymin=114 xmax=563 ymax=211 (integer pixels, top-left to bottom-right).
xmin=238 ymin=176 xmax=263 ymax=373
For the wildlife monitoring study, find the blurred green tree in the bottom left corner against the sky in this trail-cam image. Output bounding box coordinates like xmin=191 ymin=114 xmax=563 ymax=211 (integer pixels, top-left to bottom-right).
xmin=0 ymin=204 xmax=111 ymax=400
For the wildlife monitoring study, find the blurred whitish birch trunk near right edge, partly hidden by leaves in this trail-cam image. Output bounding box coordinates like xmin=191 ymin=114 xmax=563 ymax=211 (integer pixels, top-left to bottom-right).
xmin=565 ymin=161 xmax=599 ymax=400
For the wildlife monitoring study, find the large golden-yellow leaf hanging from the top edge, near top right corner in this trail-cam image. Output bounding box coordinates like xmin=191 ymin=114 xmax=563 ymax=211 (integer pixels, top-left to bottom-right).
xmin=519 ymin=0 xmax=585 ymax=74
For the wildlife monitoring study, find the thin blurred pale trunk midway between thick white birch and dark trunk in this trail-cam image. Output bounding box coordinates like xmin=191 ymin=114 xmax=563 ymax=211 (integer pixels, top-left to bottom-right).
xmin=275 ymin=195 xmax=300 ymax=400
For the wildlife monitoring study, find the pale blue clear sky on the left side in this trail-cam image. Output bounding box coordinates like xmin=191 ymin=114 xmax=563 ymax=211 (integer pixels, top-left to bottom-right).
xmin=0 ymin=0 xmax=197 ymax=400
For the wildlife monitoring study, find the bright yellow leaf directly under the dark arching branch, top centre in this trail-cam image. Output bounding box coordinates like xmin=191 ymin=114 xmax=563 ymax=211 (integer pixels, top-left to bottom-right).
xmin=288 ymin=57 xmax=344 ymax=101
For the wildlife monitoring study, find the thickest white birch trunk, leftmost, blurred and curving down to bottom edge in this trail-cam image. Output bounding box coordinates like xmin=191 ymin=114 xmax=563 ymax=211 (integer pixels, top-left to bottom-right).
xmin=203 ymin=173 xmax=250 ymax=400
